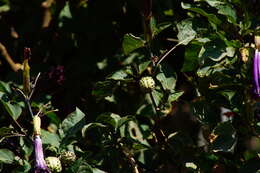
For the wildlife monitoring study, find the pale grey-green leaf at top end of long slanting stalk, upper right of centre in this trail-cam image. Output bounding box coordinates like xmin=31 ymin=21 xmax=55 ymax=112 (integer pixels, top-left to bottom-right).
xmin=177 ymin=19 xmax=197 ymax=45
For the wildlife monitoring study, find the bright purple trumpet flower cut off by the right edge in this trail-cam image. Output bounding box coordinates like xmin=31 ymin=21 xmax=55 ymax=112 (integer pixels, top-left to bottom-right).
xmin=253 ymin=49 xmax=260 ymax=97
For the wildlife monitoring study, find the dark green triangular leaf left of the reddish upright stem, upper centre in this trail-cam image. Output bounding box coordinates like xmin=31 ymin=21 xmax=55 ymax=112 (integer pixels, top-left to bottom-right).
xmin=123 ymin=34 xmax=145 ymax=55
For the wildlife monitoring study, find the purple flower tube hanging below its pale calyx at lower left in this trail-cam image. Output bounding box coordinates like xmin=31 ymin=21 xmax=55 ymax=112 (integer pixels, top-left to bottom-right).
xmin=34 ymin=135 xmax=51 ymax=173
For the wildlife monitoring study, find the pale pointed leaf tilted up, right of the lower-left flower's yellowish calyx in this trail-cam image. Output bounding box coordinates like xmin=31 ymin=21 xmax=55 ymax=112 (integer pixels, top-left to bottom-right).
xmin=61 ymin=107 xmax=85 ymax=133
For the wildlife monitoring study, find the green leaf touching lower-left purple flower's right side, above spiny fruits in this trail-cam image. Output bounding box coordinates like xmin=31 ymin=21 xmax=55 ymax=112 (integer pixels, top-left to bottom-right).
xmin=41 ymin=129 xmax=61 ymax=148
